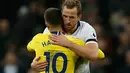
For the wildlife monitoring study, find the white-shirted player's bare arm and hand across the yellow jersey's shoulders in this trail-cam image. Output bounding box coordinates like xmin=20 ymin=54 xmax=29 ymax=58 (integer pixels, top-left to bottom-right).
xmin=50 ymin=32 xmax=103 ymax=60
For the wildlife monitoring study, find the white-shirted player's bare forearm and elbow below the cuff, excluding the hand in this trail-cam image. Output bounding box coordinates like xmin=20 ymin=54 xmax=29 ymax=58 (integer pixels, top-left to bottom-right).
xmin=66 ymin=40 xmax=98 ymax=60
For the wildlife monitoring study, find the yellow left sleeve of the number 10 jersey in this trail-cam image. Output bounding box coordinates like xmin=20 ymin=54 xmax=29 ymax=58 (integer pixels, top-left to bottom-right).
xmin=27 ymin=34 xmax=40 ymax=51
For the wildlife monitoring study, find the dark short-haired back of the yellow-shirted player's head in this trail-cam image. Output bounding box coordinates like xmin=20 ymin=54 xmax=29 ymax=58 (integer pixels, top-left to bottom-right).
xmin=44 ymin=8 xmax=63 ymax=26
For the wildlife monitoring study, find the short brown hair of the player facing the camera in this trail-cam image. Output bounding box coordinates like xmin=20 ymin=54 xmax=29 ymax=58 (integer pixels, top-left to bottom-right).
xmin=62 ymin=0 xmax=82 ymax=15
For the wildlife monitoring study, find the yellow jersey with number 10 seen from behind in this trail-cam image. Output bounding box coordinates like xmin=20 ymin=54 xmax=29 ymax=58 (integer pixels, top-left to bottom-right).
xmin=28 ymin=34 xmax=85 ymax=73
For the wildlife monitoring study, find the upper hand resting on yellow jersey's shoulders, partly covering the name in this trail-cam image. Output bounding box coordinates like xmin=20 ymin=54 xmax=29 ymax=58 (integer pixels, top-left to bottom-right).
xmin=50 ymin=34 xmax=70 ymax=47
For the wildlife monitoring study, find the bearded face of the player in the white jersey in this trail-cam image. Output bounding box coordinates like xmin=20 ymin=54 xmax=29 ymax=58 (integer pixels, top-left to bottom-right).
xmin=62 ymin=6 xmax=79 ymax=32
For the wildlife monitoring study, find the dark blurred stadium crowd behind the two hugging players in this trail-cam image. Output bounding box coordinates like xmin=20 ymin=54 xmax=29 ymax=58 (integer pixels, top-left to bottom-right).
xmin=0 ymin=0 xmax=130 ymax=73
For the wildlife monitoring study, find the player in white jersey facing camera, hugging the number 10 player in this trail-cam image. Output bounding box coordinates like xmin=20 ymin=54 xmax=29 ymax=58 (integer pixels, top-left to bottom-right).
xmin=31 ymin=0 xmax=98 ymax=73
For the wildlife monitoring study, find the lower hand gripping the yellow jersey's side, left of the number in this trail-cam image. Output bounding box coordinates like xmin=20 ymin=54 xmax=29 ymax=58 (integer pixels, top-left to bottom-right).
xmin=31 ymin=57 xmax=48 ymax=72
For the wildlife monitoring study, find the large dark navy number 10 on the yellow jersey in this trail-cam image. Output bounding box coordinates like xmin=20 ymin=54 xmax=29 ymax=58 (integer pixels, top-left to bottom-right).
xmin=44 ymin=52 xmax=68 ymax=73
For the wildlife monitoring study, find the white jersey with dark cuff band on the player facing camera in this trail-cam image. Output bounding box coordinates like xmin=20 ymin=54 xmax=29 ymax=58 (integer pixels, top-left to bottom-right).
xmin=44 ymin=21 xmax=97 ymax=73
